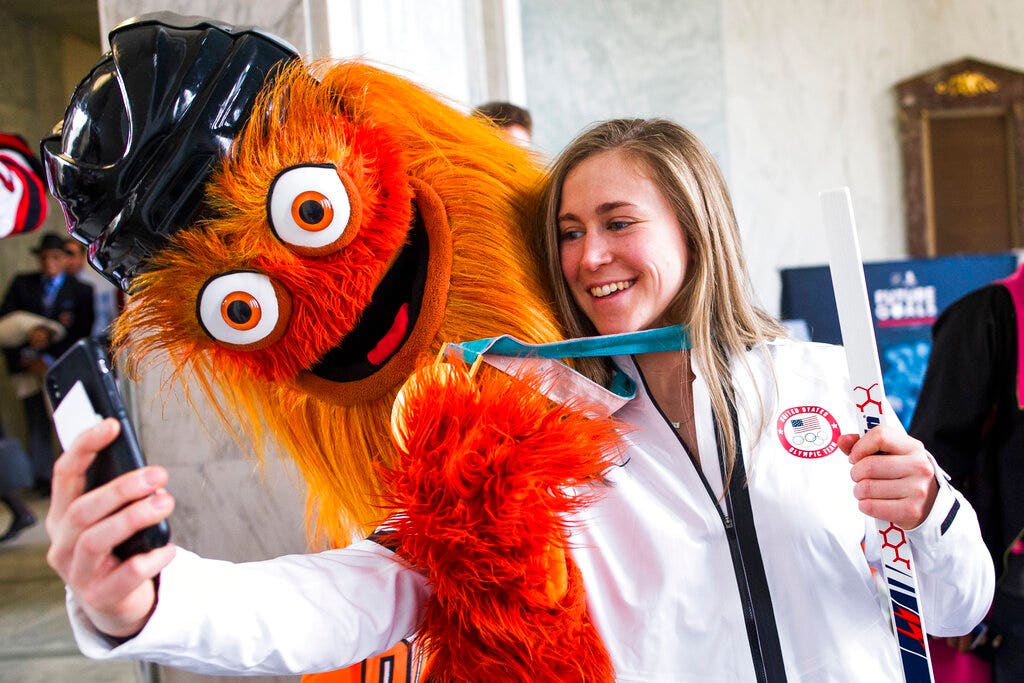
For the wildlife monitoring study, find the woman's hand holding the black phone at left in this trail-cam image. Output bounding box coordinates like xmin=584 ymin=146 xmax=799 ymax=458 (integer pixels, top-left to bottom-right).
xmin=46 ymin=418 xmax=174 ymax=638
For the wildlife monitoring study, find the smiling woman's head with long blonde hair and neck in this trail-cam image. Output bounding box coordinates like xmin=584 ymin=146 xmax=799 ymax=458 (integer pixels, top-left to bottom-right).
xmin=542 ymin=119 xmax=785 ymax=476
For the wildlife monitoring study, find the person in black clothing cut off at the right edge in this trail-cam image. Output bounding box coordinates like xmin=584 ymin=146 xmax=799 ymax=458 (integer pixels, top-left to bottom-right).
xmin=910 ymin=259 xmax=1024 ymax=683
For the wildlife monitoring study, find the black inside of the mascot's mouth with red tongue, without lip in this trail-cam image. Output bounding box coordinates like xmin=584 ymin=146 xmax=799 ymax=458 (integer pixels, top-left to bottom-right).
xmin=309 ymin=201 xmax=430 ymax=382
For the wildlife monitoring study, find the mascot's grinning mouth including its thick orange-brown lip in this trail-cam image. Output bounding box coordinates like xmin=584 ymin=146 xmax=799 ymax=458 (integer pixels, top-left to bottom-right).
xmin=298 ymin=178 xmax=452 ymax=405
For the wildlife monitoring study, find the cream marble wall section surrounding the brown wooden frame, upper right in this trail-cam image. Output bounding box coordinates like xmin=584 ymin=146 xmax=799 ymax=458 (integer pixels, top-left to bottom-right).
xmin=722 ymin=0 xmax=1024 ymax=312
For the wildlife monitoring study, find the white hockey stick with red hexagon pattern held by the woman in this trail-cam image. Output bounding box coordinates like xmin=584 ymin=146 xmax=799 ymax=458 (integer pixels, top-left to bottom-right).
xmin=820 ymin=187 xmax=934 ymax=683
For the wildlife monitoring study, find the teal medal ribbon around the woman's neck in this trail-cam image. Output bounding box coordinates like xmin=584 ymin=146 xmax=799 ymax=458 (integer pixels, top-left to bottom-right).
xmin=445 ymin=325 xmax=691 ymax=398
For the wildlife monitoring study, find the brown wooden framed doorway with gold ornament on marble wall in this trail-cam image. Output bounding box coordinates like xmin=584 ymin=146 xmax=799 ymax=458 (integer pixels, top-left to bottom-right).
xmin=896 ymin=58 xmax=1024 ymax=257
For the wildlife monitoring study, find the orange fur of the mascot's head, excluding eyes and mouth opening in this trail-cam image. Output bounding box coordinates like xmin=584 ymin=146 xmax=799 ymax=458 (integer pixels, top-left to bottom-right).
xmin=115 ymin=62 xmax=561 ymax=546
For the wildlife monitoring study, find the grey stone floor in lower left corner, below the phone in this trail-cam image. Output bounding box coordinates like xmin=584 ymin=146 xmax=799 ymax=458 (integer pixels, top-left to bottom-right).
xmin=0 ymin=499 xmax=145 ymax=683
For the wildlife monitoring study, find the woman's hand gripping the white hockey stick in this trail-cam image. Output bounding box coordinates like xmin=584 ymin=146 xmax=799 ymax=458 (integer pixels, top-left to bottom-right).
xmin=839 ymin=425 xmax=939 ymax=529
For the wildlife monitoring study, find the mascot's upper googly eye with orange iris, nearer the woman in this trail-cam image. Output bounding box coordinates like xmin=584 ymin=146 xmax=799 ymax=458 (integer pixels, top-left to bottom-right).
xmin=267 ymin=164 xmax=360 ymax=256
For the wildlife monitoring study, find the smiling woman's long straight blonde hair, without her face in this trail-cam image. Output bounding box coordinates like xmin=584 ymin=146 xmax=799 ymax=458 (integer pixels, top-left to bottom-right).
xmin=541 ymin=119 xmax=785 ymax=480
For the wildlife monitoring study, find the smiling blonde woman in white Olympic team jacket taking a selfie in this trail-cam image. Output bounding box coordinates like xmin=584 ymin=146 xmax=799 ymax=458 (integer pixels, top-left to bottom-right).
xmin=41 ymin=121 xmax=993 ymax=681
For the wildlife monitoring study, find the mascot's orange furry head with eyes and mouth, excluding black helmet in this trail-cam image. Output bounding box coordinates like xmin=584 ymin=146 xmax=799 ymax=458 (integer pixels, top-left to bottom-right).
xmin=117 ymin=57 xmax=573 ymax=545
